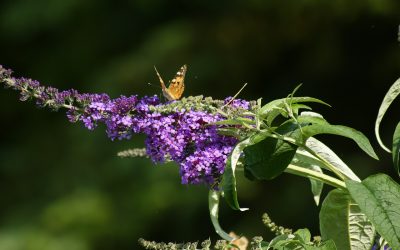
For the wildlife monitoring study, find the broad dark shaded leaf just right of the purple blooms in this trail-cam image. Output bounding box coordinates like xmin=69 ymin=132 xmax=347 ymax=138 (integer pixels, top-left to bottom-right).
xmin=243 ymin=123 xmax=301 ymax=180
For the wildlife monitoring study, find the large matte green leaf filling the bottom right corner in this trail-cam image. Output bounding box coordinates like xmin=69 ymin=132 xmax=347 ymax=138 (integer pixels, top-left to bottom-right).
xmin=346 ymin=174 xmax=400 ymax=249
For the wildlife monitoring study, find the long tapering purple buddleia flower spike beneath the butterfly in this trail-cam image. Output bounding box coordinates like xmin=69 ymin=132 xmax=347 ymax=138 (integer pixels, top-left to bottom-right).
xmin=0 ymin=66 xmax=250 ymax=187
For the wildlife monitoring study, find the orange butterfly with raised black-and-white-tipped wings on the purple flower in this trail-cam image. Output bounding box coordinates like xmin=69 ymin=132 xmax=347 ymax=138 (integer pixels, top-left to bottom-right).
xmin=154 ymin=65 xmax=186 ymax=101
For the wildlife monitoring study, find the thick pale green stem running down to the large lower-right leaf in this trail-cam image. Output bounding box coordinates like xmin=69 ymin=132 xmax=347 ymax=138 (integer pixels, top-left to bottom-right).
xmin=285 ymin=164 xmax=347 ymax=189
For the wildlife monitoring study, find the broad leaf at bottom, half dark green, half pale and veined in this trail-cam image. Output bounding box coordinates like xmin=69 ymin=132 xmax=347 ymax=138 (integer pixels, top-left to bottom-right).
xmin=319 ymin=189 xmax=375 ymax=250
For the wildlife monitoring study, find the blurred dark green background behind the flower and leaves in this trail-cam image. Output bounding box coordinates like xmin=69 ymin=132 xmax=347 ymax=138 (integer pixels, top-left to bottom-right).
xmin=0 ymin=0 xmax=400 ymax=250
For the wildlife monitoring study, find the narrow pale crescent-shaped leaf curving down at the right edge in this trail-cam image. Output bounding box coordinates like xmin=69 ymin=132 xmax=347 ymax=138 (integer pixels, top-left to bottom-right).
xmin=375 ymin=78 xmax=400 ymax=153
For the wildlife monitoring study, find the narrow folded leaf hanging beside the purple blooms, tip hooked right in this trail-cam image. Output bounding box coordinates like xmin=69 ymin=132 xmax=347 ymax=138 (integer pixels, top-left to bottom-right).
xmin=222 ymin=137 xmax=252 ymax=211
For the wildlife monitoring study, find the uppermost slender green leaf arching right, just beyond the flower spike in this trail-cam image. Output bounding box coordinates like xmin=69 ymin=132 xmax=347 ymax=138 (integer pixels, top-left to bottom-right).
xmin=258 ymin=97 xmax=329 ymax=126
